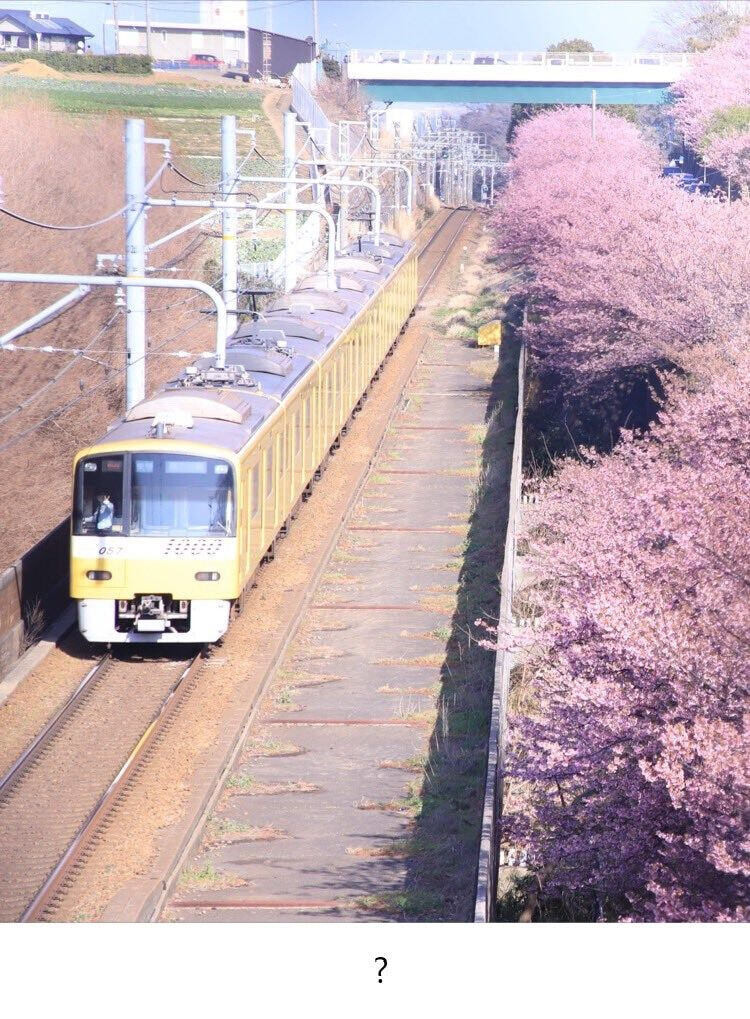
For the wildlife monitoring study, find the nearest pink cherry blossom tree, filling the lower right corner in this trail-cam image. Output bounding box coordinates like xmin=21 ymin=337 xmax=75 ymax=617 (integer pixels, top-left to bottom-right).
xmin=505 ymin=347 xmax=750 ymax=920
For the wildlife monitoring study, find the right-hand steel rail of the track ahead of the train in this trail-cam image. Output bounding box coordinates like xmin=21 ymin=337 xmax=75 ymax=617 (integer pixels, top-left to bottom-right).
xmin=20 ymin=648 xmax=203 ymax=923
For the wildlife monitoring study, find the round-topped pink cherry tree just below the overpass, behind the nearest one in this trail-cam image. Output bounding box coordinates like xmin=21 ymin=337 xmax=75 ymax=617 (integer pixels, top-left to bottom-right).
xmin=494 ymin=108 xmax=750 ymax=398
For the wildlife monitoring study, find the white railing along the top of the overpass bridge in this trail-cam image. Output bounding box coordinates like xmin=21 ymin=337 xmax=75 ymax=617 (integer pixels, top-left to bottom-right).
xmin=349 ymin=50 xmax=690 ymax=67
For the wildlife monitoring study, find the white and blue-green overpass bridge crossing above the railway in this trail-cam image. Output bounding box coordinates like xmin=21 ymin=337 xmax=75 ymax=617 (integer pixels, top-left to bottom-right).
xmin=346 ymin=50 xmax=690 ymax=106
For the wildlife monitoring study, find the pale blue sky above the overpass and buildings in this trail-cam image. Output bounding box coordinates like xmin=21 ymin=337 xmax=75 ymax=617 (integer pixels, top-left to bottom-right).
xmin=0 ymin=0 xmax=668 ymax=52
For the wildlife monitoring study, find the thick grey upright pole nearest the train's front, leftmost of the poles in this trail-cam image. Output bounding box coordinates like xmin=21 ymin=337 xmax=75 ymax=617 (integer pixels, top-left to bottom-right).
xmin=125 ymin=119 xmax=146 ymax=411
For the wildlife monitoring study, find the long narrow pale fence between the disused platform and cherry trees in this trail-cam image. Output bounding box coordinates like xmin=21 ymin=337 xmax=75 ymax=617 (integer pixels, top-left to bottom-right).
xmin=474 ymin=345 xmax=526 ymax=923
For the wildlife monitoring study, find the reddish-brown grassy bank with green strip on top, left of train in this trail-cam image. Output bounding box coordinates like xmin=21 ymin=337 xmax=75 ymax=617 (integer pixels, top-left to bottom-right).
xmin=0 ymin=72 xmax=278 ymax=568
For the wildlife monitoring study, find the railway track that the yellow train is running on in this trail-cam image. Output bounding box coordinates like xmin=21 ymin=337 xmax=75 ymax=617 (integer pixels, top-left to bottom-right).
xmin=0 ymin=209 xmax=472 ymax=922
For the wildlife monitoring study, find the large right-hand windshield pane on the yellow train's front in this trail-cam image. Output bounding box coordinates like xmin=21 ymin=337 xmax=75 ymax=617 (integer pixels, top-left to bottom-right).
xmin=129 ymin=452 xmax=234 ymax=536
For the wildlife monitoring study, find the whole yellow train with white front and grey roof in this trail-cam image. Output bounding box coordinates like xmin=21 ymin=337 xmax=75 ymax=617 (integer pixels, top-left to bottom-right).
xmin=70 ymin=235 xmax=417 ymax=643
